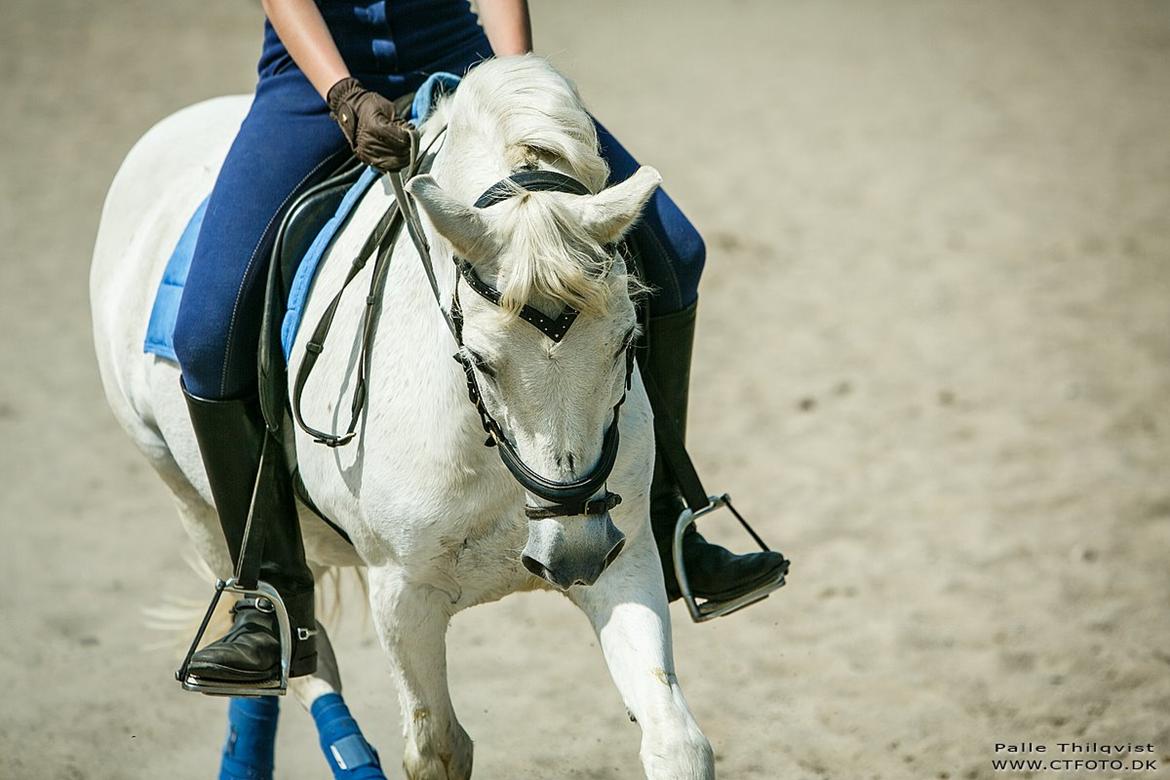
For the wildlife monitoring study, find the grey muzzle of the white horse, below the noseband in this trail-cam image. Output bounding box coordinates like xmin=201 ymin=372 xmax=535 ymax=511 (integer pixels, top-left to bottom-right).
xmin=521 ymin=512 xmax=626 ymax=591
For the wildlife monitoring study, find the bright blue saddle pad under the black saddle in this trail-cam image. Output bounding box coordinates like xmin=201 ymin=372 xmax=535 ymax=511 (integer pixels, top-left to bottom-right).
xmin=144 ymin=73 xmax=460 ymax=363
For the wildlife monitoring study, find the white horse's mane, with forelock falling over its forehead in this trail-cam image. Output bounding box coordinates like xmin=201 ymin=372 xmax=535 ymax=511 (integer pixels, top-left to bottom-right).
xmin=435 ymin=55 xmax=628 ymax=313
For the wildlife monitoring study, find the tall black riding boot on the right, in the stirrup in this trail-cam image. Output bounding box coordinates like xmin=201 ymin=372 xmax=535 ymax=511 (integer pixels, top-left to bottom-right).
xmin=642 ymin=303 xmax=789 ymax=601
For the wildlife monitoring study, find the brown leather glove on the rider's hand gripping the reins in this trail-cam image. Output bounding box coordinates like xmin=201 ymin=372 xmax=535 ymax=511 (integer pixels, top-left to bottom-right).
xmin=326 ymin=78 xmax=411 ymax=172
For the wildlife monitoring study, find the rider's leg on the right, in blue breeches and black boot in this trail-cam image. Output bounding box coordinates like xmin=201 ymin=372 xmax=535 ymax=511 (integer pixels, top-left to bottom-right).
xmin=598 ymin=123 xmax=787 ymax=601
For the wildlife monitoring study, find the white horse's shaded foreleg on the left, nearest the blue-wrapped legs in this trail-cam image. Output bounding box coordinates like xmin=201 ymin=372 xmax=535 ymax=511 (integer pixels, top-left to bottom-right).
xmin=370 ymin=567 xmax=472 ymax=780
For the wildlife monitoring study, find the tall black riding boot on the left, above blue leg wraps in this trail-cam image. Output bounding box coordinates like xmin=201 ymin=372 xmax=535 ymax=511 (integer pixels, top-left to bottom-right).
xmin=183 ymin=387 xmax=317 ymax=684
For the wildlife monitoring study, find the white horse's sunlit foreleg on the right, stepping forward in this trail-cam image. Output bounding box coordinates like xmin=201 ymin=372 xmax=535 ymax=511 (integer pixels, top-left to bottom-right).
xmin=572 ymin=529 xmax=715 ymax=780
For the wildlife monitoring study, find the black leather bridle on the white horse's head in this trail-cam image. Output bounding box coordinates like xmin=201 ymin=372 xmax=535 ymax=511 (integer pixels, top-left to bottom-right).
xmin=390 ymin=170 xmax=634 ymax=519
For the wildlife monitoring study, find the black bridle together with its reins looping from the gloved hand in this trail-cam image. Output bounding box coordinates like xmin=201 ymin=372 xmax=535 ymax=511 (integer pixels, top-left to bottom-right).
xmin=291 ymin=130 xmax=634 ymax=519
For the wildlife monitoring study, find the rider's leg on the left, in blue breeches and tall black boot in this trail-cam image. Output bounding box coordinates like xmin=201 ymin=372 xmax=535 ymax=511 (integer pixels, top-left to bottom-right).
xmin=174 ymin=68 xmax=346 ymax=683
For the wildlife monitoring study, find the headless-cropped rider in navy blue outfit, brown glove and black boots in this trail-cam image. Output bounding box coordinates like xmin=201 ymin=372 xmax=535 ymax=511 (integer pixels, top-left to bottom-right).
xmin=174 ymin=0 xmax=784 ymax=686
